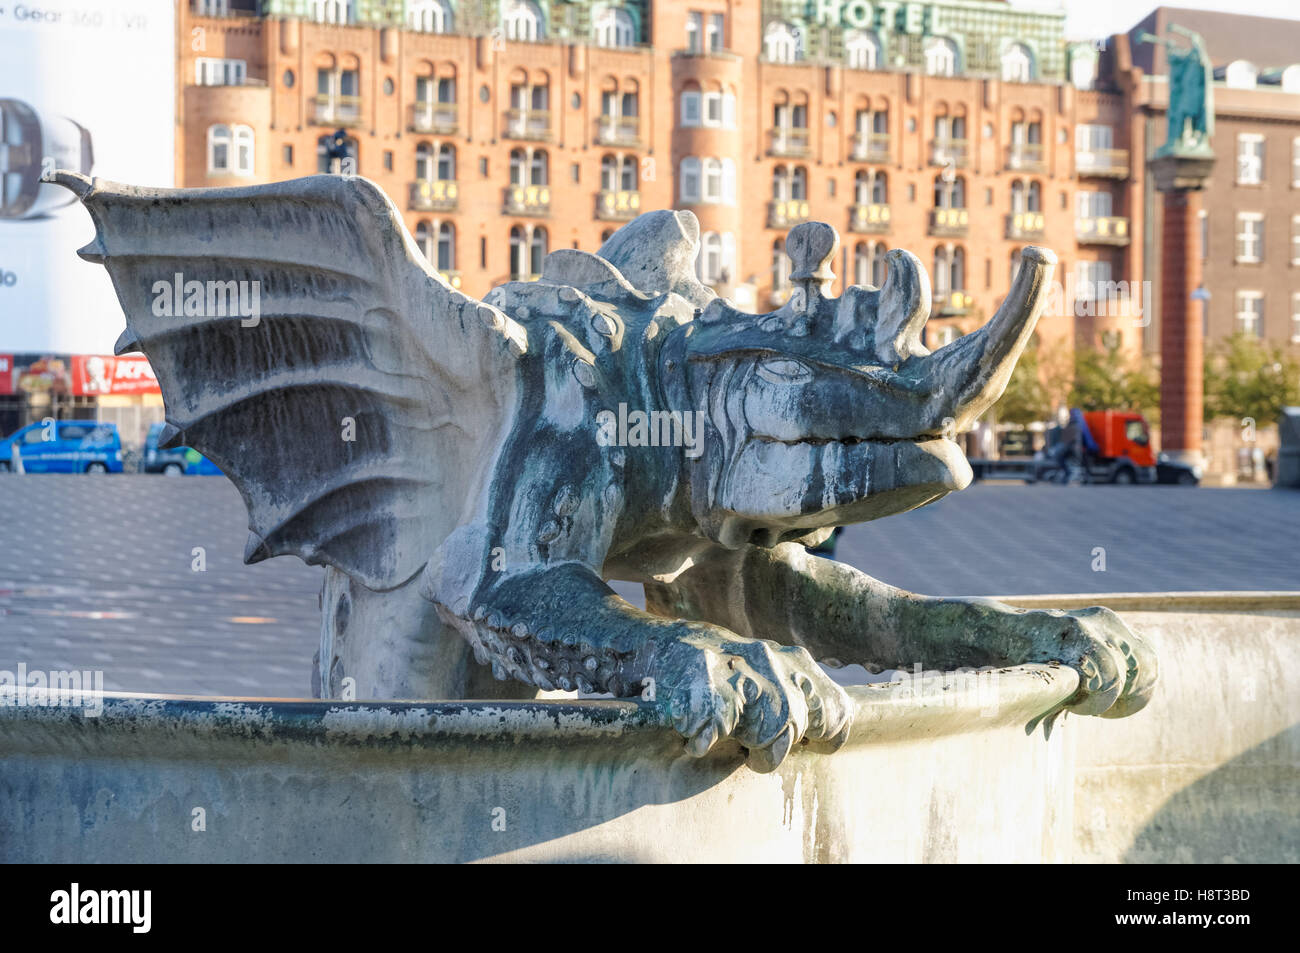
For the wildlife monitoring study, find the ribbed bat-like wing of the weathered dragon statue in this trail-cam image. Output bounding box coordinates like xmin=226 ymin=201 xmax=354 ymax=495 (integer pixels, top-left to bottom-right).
xmin=55 ymin=172 xmax=527 ymax=590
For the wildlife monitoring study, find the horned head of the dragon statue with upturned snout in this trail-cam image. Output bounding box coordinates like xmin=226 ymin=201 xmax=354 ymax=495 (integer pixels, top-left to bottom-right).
xmin=659 ymin=213 xmax=1056 ymax=545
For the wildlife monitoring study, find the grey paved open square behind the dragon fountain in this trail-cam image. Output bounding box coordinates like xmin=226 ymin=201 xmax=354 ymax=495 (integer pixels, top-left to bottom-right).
xmin=0 ymin=476 xmax=1300 ymax=697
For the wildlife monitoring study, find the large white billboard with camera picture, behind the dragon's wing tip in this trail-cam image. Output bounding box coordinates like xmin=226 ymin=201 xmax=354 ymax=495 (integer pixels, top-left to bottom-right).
xmin=0 ymin=0 xmax=176 ymax=354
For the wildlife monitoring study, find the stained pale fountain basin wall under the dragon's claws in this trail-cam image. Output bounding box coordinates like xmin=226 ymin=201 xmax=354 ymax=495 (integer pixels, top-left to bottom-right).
xmin=0 ymin=594 xmax=1300 ymax=863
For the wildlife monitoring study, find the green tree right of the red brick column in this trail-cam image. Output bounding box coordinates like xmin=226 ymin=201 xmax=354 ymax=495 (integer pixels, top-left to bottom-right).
xmin=1204 ymin=334 xmax=1300 ymax=426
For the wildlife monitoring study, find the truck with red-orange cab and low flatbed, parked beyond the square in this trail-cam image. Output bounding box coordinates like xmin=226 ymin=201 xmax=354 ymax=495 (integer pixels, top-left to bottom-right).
xmin=970 ymin=411 xmax=1157 ymax=484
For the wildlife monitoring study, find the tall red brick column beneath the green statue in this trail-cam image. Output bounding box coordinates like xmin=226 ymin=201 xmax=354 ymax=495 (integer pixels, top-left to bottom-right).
xmin=1151 ymin=155 xmax=1214 ymax=464
